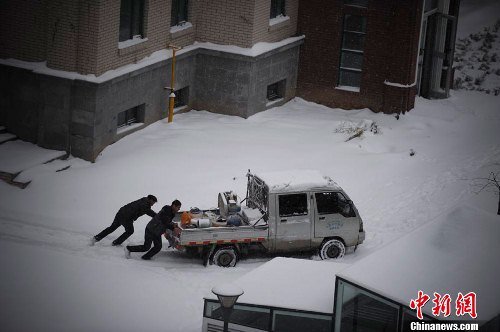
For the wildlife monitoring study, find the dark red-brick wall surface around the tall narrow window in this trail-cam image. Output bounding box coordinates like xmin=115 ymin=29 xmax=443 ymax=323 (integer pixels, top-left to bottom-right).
xmin=297 ymin=0 xmax=422 ymax=113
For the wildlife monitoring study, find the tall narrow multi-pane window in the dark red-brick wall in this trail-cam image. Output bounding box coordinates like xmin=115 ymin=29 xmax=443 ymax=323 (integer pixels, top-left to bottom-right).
xmin=338 ymin=15 xmax=366 ymax=88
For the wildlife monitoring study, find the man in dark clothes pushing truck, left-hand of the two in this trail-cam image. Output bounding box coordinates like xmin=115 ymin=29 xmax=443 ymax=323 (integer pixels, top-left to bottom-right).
xmin=90 ymin=195 xmax=158 ymax=246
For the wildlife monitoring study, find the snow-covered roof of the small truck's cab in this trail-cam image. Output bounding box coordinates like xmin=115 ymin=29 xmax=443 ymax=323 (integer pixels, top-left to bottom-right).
xmin=255 ymin=170 xmax=340 ymax=192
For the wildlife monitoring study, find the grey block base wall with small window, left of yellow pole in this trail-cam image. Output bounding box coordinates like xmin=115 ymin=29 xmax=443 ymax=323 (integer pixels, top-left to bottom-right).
xmin=83 ymin=55 xmax=196 ymax=160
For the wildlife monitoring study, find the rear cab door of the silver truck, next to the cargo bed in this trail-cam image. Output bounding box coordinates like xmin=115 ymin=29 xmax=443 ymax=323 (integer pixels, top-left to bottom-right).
xmin=275 ymin=193 xmax=311 ymax=251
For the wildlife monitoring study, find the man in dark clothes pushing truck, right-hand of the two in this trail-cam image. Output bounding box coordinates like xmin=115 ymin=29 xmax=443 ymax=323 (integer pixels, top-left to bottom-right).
xmin=125 ymin=200 xmax=181 ymax=260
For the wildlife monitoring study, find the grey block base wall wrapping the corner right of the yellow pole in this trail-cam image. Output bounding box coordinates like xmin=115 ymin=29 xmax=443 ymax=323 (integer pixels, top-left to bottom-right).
xmin=192 ymin=41 xmax=302 ymax=118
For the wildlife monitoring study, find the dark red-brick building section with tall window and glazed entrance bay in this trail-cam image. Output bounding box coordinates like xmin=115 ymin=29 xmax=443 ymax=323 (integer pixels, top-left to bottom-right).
xmin=297 ymin=0 xmax=459 ymax=113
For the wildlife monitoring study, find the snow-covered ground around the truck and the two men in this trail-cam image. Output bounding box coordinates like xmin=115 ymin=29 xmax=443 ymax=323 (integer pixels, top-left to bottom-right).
xmin=0 ymin=0 xmax=500 ymax=332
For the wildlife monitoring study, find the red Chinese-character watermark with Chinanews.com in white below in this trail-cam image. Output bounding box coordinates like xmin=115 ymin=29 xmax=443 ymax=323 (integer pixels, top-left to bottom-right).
xmin=410 ymin=290 xmax=479 ymax=331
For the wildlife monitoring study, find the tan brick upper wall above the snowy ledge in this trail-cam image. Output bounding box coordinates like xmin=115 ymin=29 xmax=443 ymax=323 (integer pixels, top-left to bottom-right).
xmin=0 ymin=0 xmax=299 ymax=75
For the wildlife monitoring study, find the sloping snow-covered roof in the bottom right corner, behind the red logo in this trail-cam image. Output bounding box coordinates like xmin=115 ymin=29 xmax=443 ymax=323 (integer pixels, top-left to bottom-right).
xmin=338 ymin=206 xmax=500 ymax=321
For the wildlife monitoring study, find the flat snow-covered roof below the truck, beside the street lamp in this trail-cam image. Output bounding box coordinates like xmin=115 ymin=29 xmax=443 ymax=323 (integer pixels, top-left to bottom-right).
xmin=206 ymin=257 xmax=348 ymax=314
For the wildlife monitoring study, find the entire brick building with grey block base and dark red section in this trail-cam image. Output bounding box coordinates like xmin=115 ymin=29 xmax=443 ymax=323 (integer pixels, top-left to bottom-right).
xmin=0 ymin=0 xmax=458 ymax=161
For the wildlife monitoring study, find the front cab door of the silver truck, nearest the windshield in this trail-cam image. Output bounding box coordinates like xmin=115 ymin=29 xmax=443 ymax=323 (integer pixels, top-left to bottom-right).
xmin=314 ymin=191 xmax=359 ymax=241
